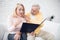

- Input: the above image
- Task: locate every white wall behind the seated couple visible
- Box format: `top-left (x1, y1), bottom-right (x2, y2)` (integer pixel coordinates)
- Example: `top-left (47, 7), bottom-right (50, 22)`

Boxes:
top-left (0, 0), bottom-right (60, 39)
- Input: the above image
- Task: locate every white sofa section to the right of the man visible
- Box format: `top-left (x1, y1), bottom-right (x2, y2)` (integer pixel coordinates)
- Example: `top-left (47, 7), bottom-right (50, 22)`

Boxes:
top-left (42, 20), bottom-right (60, 40)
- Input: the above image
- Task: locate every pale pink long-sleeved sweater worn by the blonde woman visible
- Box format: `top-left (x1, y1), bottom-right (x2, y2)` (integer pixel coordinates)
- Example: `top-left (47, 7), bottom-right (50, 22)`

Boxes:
top-left (8, 17), bottom-right (26, 33)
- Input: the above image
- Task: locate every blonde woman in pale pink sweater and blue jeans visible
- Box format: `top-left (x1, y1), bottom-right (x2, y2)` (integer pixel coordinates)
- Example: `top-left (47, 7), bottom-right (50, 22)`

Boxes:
top-left (8, 3), bottom-right (28, 40)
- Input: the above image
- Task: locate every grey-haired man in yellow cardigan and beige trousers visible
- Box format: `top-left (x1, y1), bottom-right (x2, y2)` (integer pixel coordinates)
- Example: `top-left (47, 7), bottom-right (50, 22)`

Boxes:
top-left (26, 5), bottom-right (54, 40)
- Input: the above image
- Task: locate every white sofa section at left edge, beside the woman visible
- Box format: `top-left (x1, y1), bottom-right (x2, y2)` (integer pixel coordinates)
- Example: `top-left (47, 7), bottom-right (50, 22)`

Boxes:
top-left (0, 24), bottom-right (8, 40)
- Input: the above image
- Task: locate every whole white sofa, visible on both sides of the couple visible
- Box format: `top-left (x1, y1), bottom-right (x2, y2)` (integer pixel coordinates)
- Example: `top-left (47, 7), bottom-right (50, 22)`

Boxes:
top-left (0, 21), bottom-right (60, 40)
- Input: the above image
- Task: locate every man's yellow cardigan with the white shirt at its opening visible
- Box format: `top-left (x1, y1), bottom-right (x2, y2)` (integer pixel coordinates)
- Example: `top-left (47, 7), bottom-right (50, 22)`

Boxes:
top-left (26, 12), bottom-right (43, 34)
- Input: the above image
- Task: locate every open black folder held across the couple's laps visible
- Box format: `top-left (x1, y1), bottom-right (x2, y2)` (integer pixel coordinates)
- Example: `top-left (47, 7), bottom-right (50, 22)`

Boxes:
top-left (20, 19), bottom-right (46, 33)
